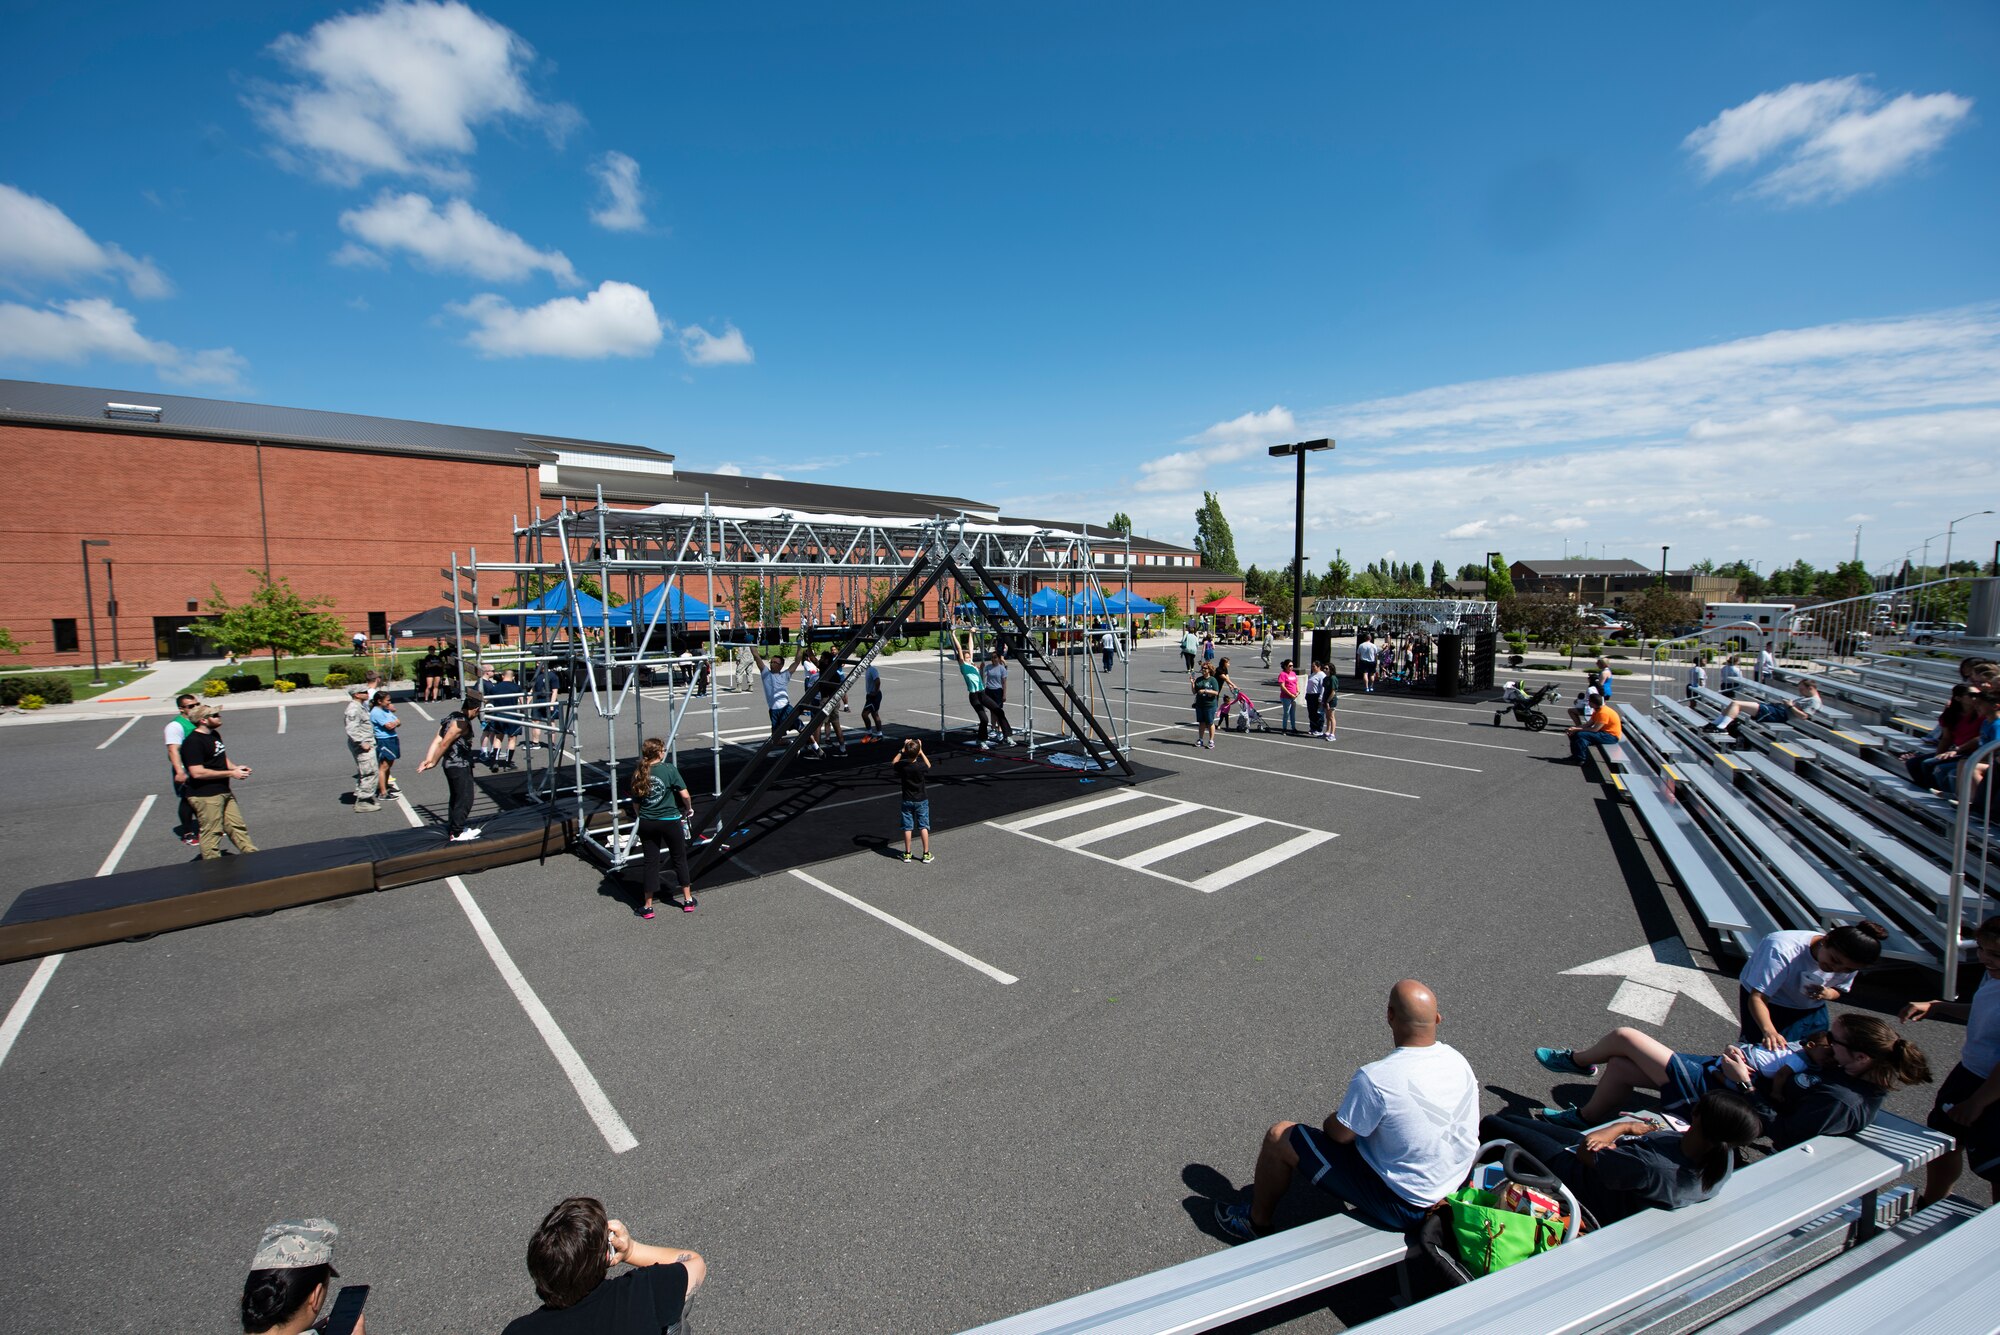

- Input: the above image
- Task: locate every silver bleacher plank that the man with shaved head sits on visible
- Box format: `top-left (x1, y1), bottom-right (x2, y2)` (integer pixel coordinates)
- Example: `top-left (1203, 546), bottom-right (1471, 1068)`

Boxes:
top-left (966, 1215), bottom-right (1408, 1335)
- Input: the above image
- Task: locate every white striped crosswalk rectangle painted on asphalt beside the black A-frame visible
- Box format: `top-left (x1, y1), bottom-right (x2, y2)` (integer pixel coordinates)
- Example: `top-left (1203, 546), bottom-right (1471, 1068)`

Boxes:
top-left (986, 789), bottom-right (1338, 895)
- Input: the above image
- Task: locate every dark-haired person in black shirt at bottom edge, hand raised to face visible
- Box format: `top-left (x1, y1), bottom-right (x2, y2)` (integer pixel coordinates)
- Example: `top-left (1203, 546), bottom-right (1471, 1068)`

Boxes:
top-left (504, 1195), bottom-right (708, 1335)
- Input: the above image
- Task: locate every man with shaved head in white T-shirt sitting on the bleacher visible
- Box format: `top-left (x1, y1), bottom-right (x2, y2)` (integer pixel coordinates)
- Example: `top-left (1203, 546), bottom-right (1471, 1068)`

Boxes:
top-left (1216, 977), bottom-right (1480, 1241)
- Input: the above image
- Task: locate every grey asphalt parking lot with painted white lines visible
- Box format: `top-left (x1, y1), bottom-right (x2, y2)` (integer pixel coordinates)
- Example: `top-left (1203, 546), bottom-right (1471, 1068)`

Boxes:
top-left (0, 648), bottom-right (1960, 1335)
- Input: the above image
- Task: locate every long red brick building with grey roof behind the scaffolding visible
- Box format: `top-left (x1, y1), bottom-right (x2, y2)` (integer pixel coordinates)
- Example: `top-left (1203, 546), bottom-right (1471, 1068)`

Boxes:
top-left (0, 380), bottom-right (1242, 666)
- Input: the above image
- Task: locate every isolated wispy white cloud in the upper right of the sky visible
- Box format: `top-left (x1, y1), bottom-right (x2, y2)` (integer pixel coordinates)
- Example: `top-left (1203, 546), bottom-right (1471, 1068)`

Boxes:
top-left (1682, 74), bottom-right (1972, 204)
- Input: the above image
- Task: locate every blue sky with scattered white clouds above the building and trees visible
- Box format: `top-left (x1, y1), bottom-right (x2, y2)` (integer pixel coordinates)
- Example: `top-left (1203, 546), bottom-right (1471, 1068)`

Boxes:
top-left (0, 2), bottom-right (2000, 568)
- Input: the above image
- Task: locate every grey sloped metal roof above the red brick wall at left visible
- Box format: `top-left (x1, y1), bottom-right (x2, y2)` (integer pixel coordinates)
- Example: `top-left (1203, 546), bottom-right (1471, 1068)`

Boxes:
top-left (0, 380), bottom-right (674, 464)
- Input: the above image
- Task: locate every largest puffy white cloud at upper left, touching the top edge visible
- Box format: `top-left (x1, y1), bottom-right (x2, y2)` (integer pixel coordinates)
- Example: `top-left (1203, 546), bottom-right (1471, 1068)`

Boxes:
top-left (250, 0), bottom-right (578, 190)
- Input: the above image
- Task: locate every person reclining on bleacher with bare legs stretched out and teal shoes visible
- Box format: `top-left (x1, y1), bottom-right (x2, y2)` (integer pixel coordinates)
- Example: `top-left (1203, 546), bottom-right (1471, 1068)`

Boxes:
top-left (1534, 1015), bottom-right (1930, 1149)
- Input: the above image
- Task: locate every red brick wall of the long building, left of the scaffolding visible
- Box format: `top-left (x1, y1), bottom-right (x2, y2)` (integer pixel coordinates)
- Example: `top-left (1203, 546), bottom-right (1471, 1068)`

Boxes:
top-left (0, 426), bottom-right (540, 666)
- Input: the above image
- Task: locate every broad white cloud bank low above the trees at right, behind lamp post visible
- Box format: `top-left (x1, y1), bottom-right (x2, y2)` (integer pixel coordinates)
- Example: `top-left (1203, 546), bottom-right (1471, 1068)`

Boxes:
top-left (1004, 306), bottom-right (2000, 570)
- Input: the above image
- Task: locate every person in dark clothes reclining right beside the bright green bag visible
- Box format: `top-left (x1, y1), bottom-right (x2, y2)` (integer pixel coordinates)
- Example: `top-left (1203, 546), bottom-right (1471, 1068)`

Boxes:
top-left (1480, 1089), bottom-right (1764, 1225)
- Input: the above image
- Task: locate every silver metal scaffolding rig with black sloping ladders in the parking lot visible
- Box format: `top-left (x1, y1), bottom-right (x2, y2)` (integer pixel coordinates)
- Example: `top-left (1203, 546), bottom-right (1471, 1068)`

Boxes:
top-left (448, 494), bottom-right (1134, 869)
